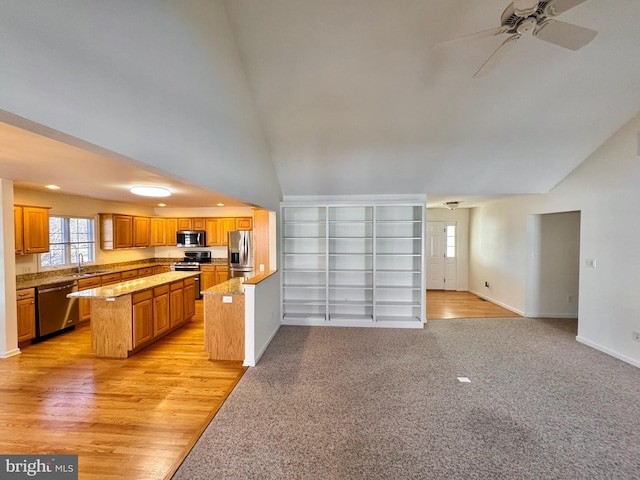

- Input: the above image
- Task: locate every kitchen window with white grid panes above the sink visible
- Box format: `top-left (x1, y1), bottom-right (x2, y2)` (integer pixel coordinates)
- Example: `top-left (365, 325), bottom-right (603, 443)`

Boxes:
top-left (40, 216), bottom-right (95, 268)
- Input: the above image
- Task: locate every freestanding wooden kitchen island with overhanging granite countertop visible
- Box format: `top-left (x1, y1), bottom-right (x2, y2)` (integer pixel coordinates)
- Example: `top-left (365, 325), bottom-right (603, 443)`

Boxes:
top-left (68, 271), bottom-right (199, 358)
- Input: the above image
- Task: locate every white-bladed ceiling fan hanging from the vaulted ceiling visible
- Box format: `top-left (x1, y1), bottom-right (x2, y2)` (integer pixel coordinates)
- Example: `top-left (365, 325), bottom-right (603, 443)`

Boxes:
top-left (434, 0), bottom-right (598, 78)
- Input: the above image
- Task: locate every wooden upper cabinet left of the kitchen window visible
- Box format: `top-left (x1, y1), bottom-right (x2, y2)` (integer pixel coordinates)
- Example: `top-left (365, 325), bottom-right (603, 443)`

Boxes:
top-left (13, 205), bottom-right (49, 254)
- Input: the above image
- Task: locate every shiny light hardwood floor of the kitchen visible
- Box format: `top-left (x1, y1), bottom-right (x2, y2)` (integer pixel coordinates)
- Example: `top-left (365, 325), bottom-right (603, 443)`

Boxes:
top-left (0, 301), bottom-right (245, 480)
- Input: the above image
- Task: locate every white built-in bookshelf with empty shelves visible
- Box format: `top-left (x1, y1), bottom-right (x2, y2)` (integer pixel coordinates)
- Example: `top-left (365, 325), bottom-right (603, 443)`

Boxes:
top-left (280, 203), bottom-right (425, 328)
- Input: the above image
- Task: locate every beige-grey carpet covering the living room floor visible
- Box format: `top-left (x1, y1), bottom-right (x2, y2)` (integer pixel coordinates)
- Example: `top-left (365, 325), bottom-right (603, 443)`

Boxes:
top-left (174, 318), bottom-right (640, 480)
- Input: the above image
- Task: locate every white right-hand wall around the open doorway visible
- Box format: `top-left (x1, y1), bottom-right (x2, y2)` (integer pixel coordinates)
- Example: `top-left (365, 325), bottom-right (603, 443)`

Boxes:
top-left (469, 115), bottom-right (640, 366)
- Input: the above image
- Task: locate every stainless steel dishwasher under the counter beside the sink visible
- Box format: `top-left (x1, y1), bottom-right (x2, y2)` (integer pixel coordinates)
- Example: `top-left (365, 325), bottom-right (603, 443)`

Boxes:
top-left (35, 280), bottom-right (80, 341)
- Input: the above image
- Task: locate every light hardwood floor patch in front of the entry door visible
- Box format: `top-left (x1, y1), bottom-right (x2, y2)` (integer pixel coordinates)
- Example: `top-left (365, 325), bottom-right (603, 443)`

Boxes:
top-left (427, 290), bottom-right (520, 320)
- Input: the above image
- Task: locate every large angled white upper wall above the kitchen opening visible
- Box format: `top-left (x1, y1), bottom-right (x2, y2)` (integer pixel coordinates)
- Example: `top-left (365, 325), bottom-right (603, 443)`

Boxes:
top-left (0, 0), bottom-right (281, 210)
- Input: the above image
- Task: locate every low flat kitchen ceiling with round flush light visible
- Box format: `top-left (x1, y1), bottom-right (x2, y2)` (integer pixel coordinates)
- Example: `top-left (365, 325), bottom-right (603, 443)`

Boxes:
top-left (0, 118), bottom-right (252, 208)
